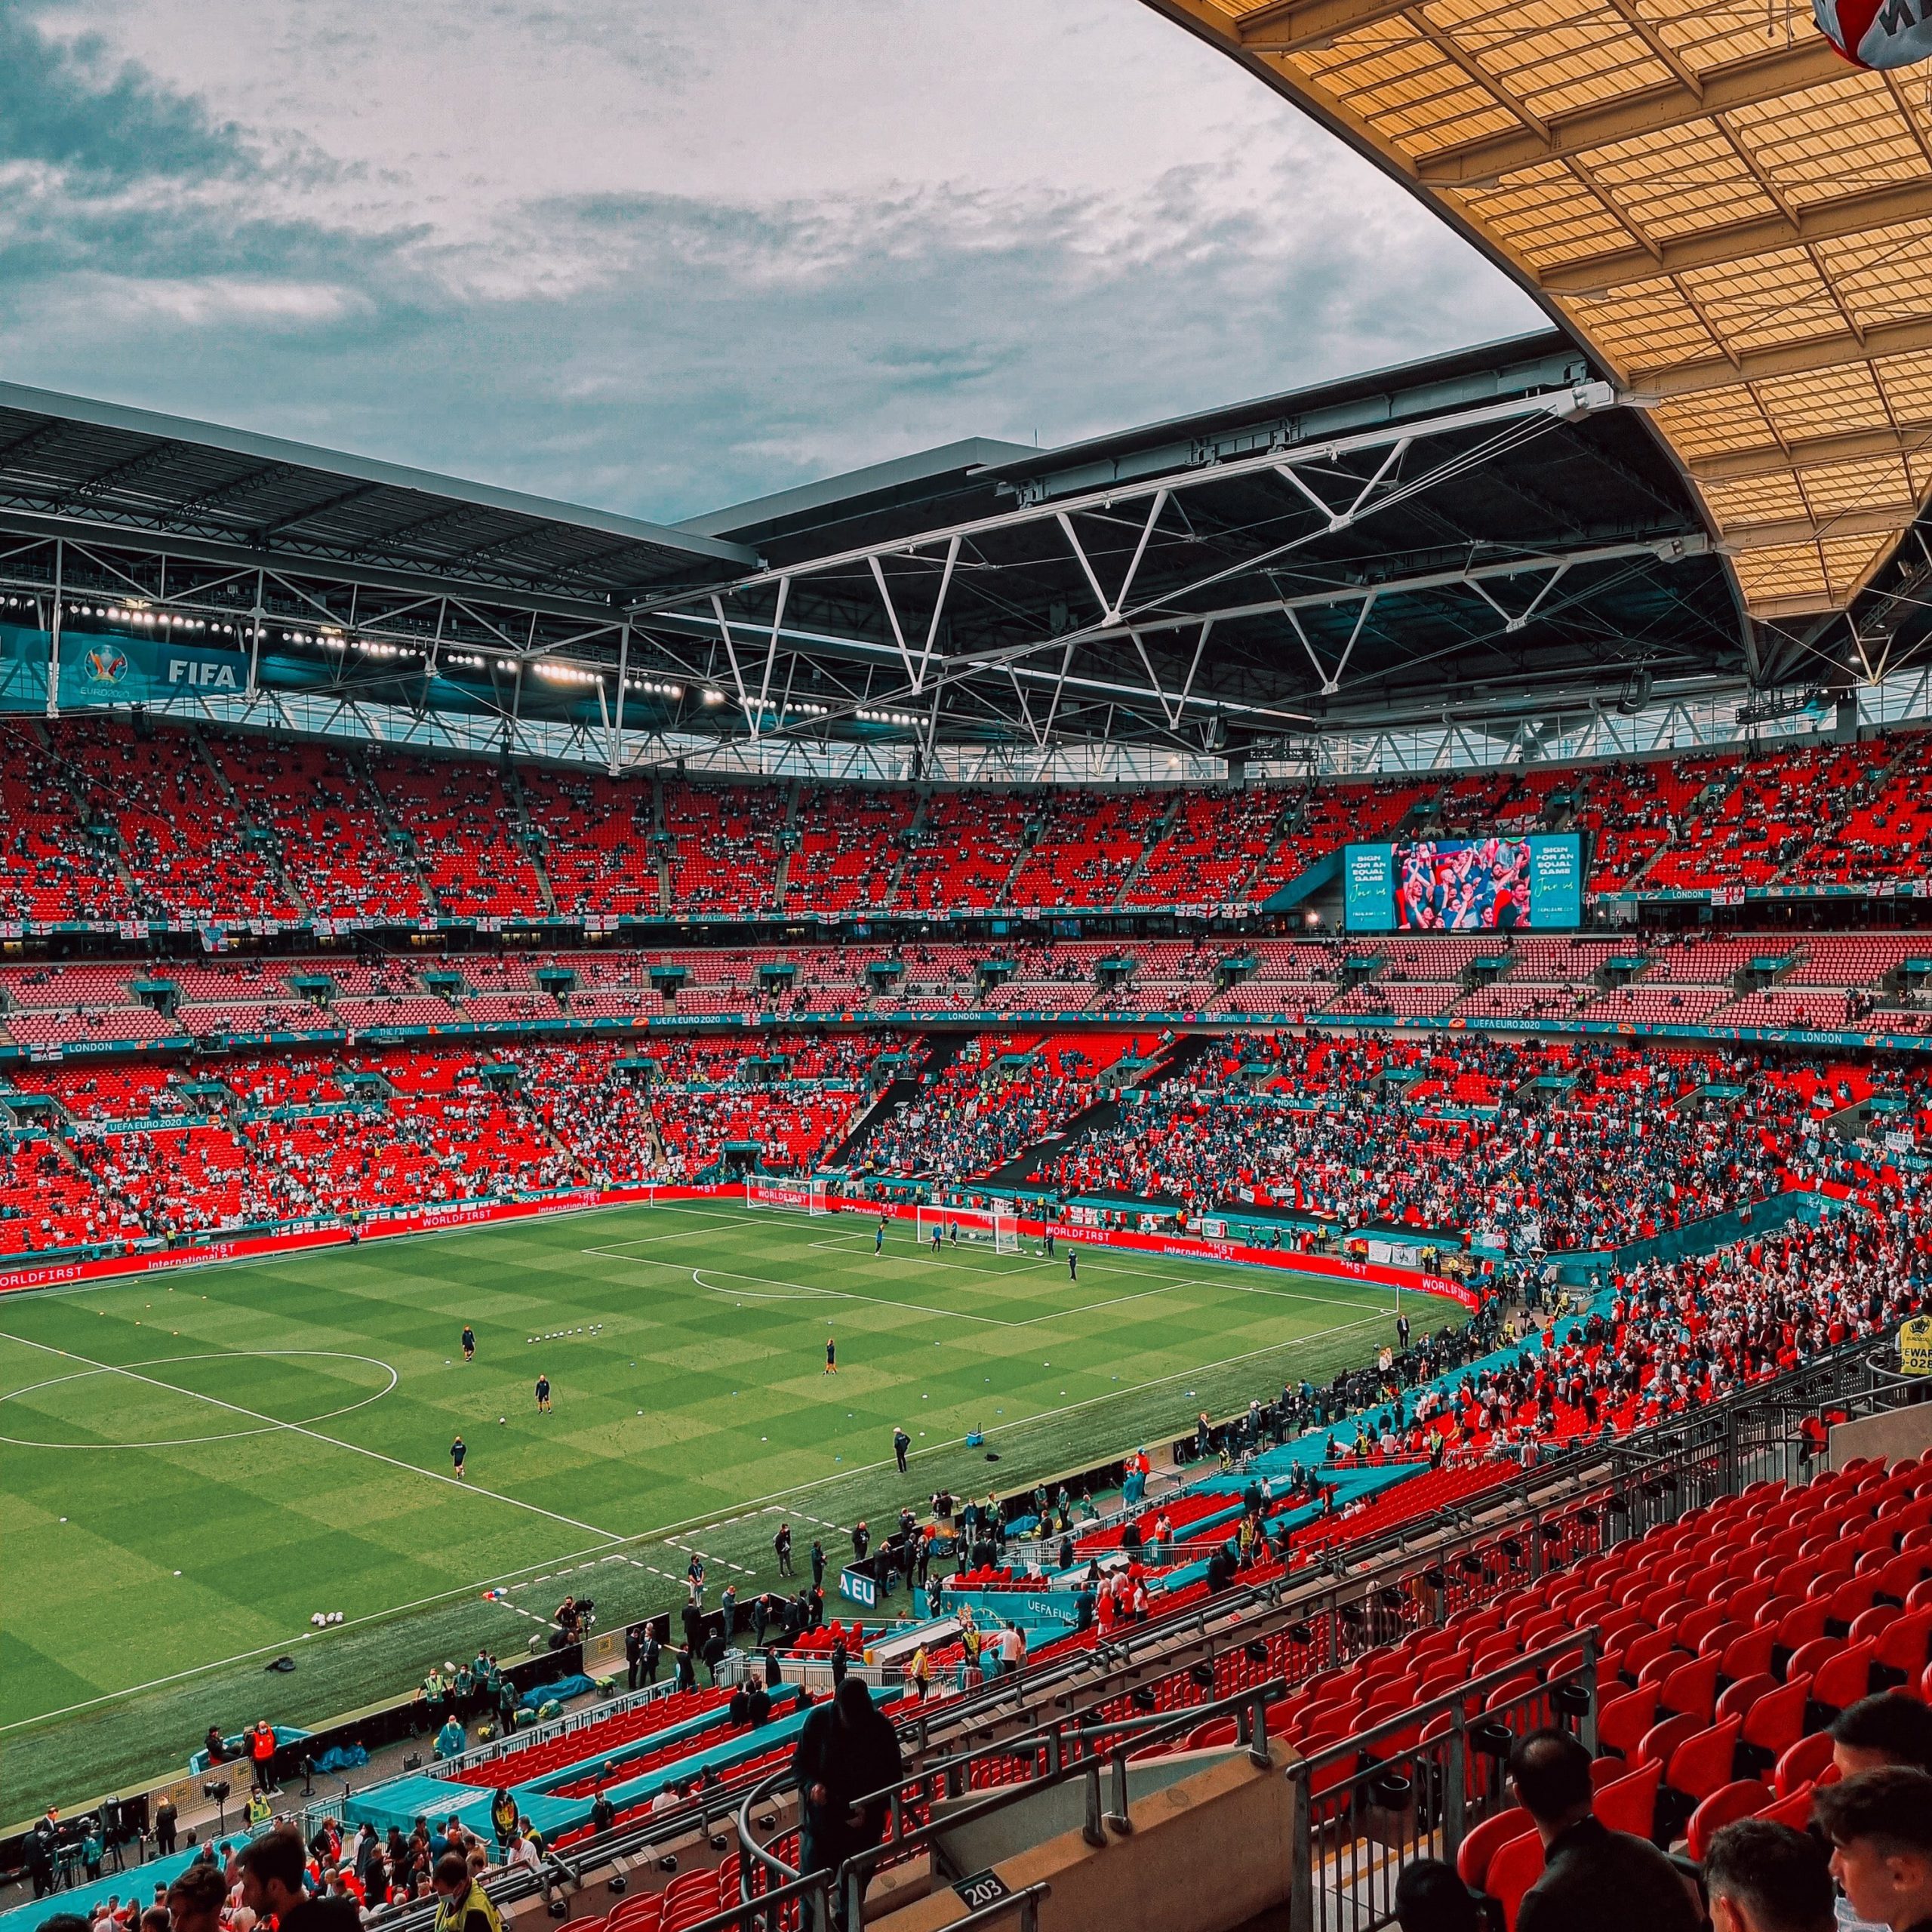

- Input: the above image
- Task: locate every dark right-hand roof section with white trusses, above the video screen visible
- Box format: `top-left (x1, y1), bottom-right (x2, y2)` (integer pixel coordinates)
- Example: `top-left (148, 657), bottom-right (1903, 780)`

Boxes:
top-left (634, 332), bottom-right (1746, 752)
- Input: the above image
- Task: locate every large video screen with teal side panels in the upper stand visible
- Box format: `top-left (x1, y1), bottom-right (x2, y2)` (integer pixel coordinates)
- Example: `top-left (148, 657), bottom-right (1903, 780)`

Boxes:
top-left (1343, 832), bottom-right (1583, 933)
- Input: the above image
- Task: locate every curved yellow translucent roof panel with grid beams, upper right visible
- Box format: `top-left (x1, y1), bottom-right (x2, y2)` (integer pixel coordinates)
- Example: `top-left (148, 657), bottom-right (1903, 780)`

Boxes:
top-left (1146, 0), bottom-right (1932, 620)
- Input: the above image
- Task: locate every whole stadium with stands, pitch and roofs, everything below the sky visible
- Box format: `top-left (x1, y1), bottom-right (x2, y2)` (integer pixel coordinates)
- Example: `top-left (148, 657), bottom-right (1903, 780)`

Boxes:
top-left (0, 42), bottom-right (1932, 1932)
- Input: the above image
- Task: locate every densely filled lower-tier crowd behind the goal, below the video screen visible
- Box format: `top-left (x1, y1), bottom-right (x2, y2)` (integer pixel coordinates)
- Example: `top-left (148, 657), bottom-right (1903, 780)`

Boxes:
top-left (1012, 1035), bottom-right (1932, 1252)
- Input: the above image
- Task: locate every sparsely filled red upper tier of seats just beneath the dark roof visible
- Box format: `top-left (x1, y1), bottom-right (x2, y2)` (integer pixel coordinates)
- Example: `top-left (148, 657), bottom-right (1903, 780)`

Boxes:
top-left (15, 717), bottom-right (1932, 943)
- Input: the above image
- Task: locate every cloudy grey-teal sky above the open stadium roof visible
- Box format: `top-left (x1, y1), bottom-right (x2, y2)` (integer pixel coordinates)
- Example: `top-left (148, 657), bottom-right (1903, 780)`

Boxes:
top-left (0, 0), bottom-right (1538, 520)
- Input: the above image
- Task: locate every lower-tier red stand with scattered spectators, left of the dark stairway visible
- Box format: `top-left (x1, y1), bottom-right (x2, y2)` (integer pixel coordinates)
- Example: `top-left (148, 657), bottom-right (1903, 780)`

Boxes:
top-left (0, 1032), bottom-right (939, 1254)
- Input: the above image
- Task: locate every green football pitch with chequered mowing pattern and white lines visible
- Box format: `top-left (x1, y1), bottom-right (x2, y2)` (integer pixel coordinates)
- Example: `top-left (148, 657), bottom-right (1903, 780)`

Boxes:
top-left (0, 1201), bottom-right (1406, 1826)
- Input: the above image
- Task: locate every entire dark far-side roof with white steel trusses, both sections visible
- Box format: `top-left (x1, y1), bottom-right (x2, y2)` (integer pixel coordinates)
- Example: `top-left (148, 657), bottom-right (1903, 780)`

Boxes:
top-left (0, 331), bottom-right (1750, 763)
